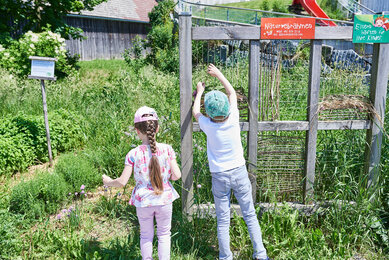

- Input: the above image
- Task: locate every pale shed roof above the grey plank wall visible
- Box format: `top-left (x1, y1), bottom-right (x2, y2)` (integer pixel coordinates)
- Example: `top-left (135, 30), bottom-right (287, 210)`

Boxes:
top-left (76, 0), bottom-right (157, 22)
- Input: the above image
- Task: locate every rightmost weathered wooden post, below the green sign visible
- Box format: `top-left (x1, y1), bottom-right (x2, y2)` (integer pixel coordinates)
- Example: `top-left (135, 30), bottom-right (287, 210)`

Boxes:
top-left (364, 43), bottom-right (389, 189)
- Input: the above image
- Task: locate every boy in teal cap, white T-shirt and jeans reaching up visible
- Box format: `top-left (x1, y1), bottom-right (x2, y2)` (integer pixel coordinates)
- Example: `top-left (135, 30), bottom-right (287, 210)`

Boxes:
top-left (192, 64), bottom-right (269, 260)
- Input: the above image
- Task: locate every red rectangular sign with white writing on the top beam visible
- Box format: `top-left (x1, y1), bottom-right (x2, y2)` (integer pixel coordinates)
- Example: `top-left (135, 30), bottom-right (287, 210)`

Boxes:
top-left (261, 18), bottom-right (315, 39)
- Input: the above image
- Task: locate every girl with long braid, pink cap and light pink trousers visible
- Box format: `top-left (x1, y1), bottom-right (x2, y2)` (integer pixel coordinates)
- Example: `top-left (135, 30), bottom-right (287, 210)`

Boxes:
top-left (103, 106), bottom-right (181, 260)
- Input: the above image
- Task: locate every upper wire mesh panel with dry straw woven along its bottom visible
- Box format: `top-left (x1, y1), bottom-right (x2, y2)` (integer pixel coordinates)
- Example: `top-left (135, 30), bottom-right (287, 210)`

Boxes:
top-left (319, 44), bottom-right (373, 120)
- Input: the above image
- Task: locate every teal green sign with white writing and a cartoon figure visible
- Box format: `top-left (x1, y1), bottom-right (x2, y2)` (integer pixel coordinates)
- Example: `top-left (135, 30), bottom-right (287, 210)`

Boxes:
top-left (353, 14), bottom-right (389, 43)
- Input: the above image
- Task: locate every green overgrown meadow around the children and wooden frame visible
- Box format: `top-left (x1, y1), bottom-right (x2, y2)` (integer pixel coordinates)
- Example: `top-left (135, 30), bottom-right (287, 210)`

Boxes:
top-left (0, 60), bottom-right (389, 259)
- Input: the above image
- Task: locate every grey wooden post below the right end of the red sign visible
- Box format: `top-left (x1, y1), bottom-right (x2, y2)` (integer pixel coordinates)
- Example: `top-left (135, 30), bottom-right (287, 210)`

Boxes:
top-left (304, 40), bottom-right (322, 203)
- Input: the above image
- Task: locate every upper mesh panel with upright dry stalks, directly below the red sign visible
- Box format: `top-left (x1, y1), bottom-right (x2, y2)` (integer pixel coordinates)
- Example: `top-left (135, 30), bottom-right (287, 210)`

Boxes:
top-left (259, 40), bottom-right (309, 121)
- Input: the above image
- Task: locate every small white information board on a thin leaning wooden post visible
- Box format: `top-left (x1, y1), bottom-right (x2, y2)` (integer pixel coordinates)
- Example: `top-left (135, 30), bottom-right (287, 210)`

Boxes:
top-left (28, 56), bottom-right (57, 167)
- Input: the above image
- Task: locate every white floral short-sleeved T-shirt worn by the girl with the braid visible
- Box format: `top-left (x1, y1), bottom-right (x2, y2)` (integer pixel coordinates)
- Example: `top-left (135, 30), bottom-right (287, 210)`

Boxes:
top-left (125, 143), bottom-right (179, 207)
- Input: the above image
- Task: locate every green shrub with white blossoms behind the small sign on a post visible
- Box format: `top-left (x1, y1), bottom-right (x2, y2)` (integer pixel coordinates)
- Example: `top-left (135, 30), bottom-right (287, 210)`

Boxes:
top-left (0, 29), bottom-right (78, 77)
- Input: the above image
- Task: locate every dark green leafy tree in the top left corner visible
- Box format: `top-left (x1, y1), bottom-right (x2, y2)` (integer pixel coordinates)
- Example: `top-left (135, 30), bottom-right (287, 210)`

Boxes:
top-left (0, 0), bottom-right (107, 40)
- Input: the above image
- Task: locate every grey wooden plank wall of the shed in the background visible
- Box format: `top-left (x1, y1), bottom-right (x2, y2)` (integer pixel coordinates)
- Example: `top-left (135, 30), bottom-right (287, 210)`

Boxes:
top-left (66, 17), bottom-right (149, 60)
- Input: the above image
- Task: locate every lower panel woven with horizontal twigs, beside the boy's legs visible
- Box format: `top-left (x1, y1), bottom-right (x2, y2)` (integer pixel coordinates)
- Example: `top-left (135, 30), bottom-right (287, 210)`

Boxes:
top-left (257, 132), bottom-right (305, 201)
